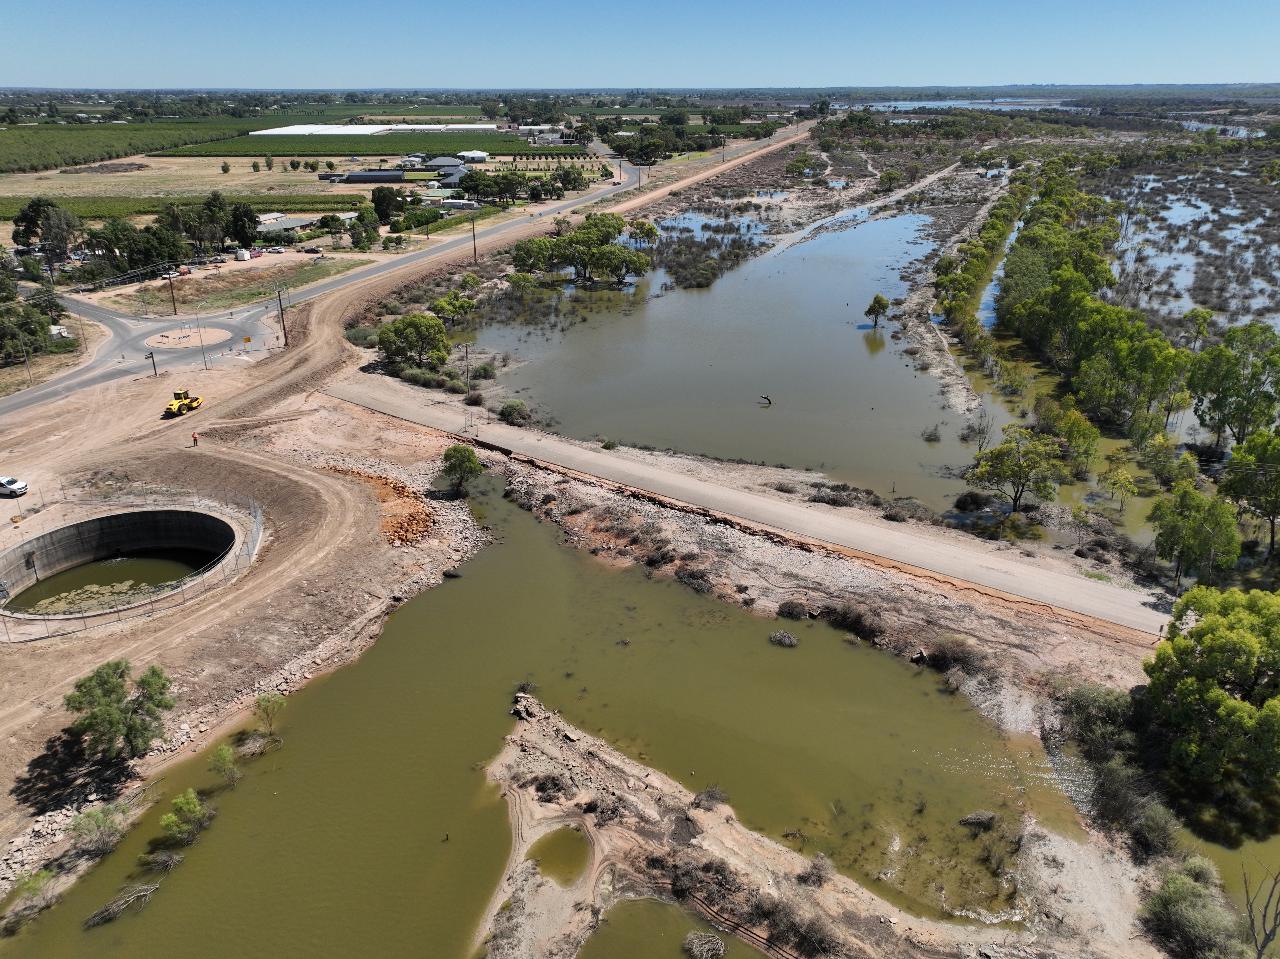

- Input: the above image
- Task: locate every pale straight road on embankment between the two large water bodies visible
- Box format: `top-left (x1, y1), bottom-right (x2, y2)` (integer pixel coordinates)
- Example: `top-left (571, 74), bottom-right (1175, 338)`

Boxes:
top-left (325, 375), bottom-right (1169, 634)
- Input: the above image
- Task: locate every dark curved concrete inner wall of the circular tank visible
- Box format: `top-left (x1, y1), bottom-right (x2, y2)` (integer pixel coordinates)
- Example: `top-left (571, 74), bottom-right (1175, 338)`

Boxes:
top-left (0, 510), bottom-right (238, 606)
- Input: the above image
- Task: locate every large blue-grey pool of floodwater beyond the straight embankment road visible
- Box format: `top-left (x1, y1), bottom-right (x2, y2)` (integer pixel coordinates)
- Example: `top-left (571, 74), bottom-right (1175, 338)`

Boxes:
top-left (476, 211), bottom-right (1010, 510)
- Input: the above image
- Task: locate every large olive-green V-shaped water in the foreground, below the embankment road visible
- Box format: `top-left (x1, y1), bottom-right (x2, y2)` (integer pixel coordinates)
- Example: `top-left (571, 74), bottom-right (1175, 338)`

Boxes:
top-left (0, 478), bottom-right (1078, 959)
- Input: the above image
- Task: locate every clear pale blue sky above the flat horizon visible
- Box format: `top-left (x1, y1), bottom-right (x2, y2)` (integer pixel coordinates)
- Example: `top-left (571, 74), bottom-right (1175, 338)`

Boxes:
top-left (0, 0), bottom-right (1280, 88)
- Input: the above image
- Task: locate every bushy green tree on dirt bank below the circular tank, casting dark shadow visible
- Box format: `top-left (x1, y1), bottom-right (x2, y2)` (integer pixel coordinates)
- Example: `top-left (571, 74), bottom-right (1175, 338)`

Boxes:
top-left (63, 659), bottom-right (174, 759)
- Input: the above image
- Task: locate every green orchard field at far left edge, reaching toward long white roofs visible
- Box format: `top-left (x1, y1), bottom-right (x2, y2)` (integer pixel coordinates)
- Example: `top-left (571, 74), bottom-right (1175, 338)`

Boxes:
top-left (0, 115), bottom-right (340, 173)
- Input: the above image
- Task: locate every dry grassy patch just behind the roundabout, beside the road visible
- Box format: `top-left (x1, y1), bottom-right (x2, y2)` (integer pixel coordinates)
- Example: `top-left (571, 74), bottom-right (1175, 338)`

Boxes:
top-left (108, 257), bottom-right (372, 314)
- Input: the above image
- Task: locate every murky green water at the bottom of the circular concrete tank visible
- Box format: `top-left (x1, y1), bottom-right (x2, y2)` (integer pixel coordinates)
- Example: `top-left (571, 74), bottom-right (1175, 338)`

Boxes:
top-left (5, 549), bottom-right (212, 613)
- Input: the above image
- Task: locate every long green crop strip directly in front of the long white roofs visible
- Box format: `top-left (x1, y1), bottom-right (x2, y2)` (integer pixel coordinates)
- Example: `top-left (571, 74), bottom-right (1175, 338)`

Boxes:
top-left (154, 133), bottom-right (584, 157)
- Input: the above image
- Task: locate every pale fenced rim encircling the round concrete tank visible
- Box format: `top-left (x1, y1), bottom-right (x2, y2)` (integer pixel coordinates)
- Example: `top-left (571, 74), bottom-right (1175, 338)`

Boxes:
top-left (0, 488), bottom-right (265, 643)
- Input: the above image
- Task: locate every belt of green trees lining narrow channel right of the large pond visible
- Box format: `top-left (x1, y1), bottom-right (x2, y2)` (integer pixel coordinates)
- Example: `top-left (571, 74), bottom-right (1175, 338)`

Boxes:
top-left (938, 159), bottom-right (1280, 588)
